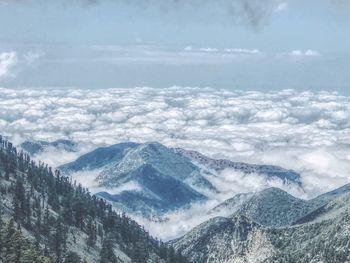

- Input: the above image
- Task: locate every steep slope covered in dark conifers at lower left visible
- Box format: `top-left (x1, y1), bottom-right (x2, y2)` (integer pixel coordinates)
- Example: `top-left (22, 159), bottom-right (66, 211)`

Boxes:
top-left (0, 136), bottom-right (187, 263)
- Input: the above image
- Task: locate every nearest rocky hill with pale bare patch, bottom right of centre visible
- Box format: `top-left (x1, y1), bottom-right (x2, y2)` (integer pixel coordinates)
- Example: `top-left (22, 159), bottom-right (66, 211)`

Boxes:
top-left (170, 215), bottom-right (274, 263)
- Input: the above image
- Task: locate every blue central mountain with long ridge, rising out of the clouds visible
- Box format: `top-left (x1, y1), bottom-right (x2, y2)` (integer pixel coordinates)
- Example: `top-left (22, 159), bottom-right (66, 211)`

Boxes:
top-left (59, 142), bottom-right (300, 218)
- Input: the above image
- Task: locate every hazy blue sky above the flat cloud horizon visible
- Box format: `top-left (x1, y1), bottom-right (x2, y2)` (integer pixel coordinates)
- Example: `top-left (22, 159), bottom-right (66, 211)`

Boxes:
top-left (0, 0), bottom-right (350, 93)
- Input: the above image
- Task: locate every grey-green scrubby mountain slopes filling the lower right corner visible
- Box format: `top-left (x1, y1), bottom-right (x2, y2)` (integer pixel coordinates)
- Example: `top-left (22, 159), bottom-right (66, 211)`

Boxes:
top-left (170, 186), bottom-right (350, 263)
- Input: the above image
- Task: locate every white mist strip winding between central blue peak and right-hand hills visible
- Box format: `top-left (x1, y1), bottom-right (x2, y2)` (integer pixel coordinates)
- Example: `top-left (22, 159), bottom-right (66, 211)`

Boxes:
top-left (134, 169), bottom-right (304, 240)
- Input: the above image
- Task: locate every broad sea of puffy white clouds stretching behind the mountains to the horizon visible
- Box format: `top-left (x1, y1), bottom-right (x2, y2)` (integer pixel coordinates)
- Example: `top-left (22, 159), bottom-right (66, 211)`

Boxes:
top-left (0, 87), bottom-right (350, 200)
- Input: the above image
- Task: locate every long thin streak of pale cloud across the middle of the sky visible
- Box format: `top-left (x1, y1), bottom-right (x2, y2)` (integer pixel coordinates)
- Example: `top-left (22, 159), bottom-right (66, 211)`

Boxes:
top-left (57, 43), bottom-right (323, 65)
